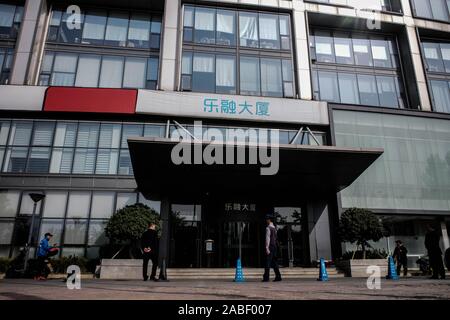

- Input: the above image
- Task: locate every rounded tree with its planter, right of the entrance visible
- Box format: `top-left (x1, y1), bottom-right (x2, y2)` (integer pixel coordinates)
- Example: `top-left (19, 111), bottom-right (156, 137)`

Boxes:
top-left (337, 208), bottom-right (387, 277)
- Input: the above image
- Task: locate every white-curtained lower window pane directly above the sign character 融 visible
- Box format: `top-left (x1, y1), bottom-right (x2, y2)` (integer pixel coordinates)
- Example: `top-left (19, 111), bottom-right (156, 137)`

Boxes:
top-left (216, 56), bottom-right (236, 94)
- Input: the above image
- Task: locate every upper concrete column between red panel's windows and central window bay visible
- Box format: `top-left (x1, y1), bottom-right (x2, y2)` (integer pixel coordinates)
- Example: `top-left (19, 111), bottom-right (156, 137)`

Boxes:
top-left (159, 0), bottom-right (181, 91)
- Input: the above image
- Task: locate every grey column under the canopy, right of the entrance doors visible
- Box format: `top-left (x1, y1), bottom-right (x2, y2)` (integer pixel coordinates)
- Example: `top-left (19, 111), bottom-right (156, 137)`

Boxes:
top-left (307, 201), bottom-right (332, 261)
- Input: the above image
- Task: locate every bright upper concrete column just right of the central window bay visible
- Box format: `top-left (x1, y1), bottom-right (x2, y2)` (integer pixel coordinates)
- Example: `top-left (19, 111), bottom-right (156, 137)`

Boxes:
top-left (292, 1), bottom-right (312, 100)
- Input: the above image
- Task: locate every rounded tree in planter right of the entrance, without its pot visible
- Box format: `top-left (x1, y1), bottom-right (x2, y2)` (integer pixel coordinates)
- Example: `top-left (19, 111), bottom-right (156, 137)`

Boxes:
top-left (338, 208), bottom-right (384, 259)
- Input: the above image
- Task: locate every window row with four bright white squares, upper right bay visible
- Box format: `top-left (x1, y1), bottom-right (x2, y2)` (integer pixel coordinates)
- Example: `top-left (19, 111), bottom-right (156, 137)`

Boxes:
top-left (310, 30), bottom-right (399, 68)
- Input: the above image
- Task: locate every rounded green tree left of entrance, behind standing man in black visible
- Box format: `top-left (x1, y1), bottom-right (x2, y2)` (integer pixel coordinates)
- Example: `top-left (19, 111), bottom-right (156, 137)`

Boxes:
top-left (105, 203), bottom-right (161, 258)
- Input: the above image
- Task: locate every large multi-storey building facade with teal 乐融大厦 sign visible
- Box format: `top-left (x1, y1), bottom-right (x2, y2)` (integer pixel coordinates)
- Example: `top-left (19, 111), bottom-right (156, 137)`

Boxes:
top-left (0, 0), bottom-right (450, 267)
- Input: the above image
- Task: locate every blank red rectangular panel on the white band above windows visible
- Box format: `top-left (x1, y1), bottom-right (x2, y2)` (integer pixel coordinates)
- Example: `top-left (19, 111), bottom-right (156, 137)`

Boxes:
top-left (44, 87), bottom-right (138, 114)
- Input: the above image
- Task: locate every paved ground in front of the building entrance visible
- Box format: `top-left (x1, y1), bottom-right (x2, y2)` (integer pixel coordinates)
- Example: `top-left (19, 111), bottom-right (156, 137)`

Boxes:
top-left (0, 277), bottom-right (450, 300)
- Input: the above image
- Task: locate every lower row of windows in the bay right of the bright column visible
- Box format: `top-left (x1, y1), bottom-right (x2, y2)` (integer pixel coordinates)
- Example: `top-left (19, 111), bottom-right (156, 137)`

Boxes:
top-left (313, 71), bottom-right (404, 108)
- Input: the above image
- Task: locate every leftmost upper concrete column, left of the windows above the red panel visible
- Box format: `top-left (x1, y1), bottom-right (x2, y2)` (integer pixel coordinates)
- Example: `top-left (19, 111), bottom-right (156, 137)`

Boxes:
top-left (10, 0), bottom-right (45, 85)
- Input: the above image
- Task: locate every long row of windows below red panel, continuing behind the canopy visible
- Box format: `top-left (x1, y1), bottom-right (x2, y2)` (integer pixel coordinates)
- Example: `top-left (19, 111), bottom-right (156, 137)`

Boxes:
top-left (0, 120), bottom-right (325, 175)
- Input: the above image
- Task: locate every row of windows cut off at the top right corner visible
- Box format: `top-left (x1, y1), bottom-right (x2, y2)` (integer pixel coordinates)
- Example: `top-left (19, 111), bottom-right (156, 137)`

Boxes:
top-left (411, 0), bottom-right (450, 22)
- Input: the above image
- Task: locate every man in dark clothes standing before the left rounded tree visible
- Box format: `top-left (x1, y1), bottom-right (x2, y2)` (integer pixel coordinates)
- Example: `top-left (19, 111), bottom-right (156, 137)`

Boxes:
top-left (141, 222), bottom-right (158, 281)
